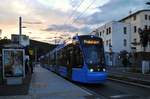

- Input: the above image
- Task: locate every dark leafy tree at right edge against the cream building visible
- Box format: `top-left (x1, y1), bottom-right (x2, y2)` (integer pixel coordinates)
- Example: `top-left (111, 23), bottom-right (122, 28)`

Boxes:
top-left (138, 29), bottom-right (150, 52)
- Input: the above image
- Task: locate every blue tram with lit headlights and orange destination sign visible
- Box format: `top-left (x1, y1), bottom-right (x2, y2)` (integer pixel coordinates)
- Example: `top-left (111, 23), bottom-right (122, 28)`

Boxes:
top-left (42, 35), bottom-right (107, 83)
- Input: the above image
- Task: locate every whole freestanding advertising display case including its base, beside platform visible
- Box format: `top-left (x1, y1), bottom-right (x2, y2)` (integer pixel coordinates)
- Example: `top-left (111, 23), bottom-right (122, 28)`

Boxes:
top-left (2, 44), bottom-right (25, 85)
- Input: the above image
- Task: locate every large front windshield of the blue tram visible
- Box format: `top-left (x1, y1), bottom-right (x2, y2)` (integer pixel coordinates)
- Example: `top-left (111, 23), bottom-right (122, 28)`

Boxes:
top-left (83, 45), bottom-right (104, 65)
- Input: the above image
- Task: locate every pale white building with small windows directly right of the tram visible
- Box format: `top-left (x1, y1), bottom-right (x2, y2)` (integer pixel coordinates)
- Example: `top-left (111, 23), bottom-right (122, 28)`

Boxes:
top-left (92, 21), bottom-right (131, 65)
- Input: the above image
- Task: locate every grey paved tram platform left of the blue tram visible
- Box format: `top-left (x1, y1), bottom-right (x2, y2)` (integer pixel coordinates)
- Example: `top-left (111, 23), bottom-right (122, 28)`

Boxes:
top-left (0, 66), bottom-right (92, 99)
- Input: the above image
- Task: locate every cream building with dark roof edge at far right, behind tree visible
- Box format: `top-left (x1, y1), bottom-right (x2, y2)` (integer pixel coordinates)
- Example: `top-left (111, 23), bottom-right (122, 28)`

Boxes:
top-left (119, 9), bottom-right (150, 52)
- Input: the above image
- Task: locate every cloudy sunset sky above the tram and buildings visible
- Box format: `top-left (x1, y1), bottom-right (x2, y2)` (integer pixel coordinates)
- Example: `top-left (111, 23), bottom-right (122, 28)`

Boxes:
top-left (0, 0), bottom-right (149, 43)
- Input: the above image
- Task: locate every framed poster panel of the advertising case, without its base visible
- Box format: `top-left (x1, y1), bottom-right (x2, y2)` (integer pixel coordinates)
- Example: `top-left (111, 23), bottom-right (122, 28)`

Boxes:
top-left (3, 49), bottom-right (25, 78)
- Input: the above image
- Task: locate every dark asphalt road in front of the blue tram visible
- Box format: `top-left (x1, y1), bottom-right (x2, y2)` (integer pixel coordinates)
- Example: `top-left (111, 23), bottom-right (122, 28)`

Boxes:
top-left (77, 80), bottom-right (150, 99)
